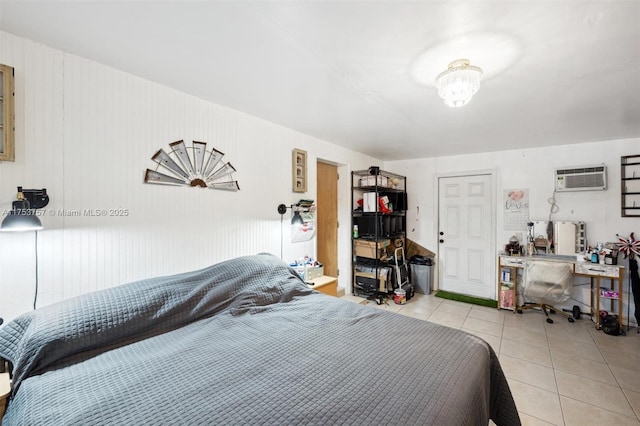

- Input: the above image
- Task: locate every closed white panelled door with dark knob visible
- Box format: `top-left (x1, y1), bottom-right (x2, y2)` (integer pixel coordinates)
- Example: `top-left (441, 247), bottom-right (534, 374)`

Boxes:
top-left (438, 174), bottom-right (496, 299)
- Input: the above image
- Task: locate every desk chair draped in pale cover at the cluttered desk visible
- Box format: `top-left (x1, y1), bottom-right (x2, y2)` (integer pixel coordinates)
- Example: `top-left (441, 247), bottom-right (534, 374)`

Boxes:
top-left (517, 261), bottom-right (574, 324)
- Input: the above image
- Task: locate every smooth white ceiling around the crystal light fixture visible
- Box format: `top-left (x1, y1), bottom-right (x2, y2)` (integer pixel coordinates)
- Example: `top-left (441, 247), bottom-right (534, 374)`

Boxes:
top-left (0, 0), bottom-right (640, 160)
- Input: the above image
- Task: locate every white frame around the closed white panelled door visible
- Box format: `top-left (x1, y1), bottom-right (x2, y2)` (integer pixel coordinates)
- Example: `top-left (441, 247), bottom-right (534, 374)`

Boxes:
top-left (433, 169), bottom-right (498, 300)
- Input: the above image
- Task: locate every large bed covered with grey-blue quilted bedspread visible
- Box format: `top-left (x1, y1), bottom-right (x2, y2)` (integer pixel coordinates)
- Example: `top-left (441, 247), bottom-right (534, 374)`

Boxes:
top-left (0, 254), bottom-right (520, 426)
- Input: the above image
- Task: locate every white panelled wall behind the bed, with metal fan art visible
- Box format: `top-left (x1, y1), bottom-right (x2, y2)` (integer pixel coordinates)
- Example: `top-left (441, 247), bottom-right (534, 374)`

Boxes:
top-left (0, 32), bottom-right (379, 320)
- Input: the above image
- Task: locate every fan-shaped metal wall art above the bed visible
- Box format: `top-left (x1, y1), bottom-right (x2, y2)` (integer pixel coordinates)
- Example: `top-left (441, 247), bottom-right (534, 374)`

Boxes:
top-left (144, 140), bottom-right (240, 192)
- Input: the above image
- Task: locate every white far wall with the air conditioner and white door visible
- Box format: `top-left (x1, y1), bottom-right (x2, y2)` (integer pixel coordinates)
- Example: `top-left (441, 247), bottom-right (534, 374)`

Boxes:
top-left (384, 139), bottom-right (640, 322)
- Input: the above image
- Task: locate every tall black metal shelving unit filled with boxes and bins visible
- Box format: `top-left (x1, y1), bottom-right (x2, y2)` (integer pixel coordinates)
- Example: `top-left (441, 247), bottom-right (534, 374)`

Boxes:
top-left (351, 167), bottom-right (407, 297)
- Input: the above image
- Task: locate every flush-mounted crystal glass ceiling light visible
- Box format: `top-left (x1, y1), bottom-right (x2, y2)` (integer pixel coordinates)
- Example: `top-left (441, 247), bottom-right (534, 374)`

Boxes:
top-left (436, 59), bottom-right (482, 107)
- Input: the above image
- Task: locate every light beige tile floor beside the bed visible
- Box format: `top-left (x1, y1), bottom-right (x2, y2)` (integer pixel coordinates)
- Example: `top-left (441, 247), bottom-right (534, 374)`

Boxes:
top-left (342, 294), bottom-right (640, 426)
